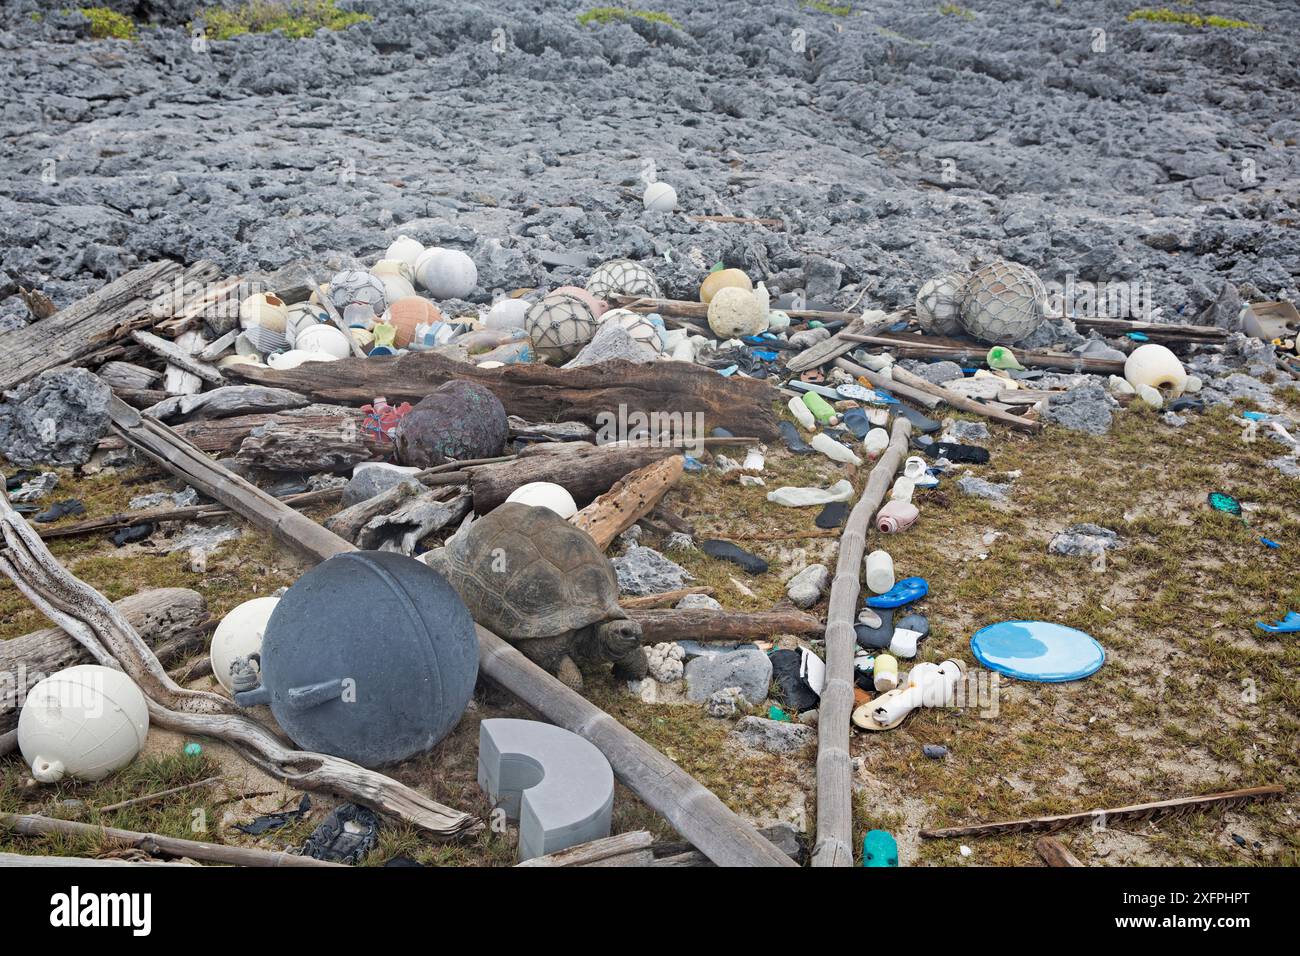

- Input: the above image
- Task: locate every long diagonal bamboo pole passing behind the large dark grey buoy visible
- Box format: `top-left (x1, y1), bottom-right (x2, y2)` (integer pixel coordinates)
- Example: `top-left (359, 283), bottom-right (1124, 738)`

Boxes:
top-left (104, 395), bottom-right (793, 866)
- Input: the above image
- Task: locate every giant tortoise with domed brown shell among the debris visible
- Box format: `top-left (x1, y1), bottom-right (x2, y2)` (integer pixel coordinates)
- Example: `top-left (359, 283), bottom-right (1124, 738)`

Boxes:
top-left (436, 502), bottom-right (649, 688)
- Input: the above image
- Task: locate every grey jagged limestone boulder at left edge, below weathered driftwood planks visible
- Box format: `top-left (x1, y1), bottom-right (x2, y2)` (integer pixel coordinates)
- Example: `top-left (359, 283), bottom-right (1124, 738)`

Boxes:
top-left (0, 368), bottom-right (113, 467)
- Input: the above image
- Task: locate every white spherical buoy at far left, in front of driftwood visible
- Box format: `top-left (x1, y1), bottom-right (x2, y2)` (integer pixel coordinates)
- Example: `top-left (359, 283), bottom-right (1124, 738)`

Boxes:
top-left (18, 663), bottom-right (150, 783)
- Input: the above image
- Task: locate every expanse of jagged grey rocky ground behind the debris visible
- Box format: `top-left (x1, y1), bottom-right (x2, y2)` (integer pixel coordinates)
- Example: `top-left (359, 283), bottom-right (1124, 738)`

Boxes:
top-left (0, 0), bottom-right (1300, 328)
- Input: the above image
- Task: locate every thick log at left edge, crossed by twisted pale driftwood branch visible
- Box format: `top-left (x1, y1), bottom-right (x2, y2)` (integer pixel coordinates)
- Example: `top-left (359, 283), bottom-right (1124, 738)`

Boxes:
top-left (0, 588), bottom-right (208, 732)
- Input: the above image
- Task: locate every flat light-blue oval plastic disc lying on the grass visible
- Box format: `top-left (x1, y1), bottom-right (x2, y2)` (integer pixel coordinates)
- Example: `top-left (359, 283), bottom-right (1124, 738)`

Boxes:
top-left (971, 620), bottom-right (1106, 683)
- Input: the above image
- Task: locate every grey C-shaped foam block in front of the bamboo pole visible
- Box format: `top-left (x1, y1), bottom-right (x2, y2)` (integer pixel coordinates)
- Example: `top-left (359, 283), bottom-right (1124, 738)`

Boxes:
top-left (478, 718), bottom-right (614, 861)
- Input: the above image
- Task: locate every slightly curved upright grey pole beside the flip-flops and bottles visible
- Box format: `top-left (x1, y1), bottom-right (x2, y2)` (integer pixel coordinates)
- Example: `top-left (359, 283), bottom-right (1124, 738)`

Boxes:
top-left (813, 418), bottom-right (911, 866)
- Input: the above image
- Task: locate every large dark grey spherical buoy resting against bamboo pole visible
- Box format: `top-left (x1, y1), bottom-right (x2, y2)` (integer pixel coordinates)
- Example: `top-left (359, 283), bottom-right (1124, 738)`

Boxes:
top-left (235, 551), bottom-right (478, 767)
